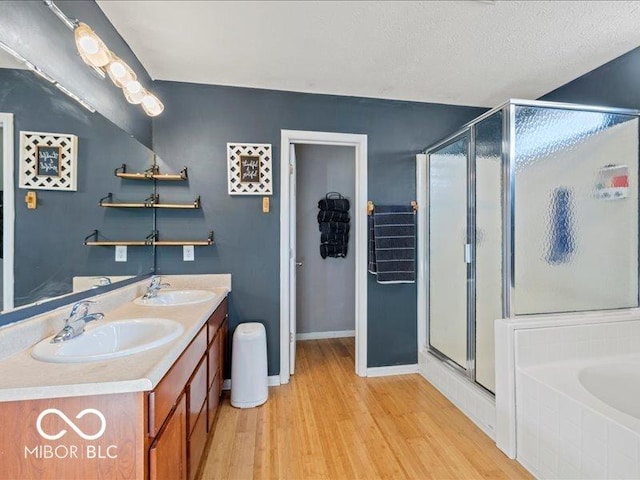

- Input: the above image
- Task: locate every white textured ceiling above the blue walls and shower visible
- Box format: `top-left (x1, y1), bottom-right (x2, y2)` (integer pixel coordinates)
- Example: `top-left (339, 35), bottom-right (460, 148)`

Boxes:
top-left (96, 0), bottom-right (640, 107)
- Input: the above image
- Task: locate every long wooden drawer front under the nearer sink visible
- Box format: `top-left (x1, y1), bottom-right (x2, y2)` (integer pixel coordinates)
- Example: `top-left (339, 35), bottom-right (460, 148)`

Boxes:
top-left (149, 327), bottom-right (207, 437)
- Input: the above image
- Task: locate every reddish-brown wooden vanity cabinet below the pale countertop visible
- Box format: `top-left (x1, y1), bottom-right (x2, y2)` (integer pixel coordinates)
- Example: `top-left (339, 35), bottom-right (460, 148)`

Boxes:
top-left (0, 299), bottom-right (227, 480)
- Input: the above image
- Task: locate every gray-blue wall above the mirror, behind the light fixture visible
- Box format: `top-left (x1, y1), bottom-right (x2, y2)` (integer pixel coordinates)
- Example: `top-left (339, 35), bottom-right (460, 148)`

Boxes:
top-left (0, 0), bottom-right (151, 146)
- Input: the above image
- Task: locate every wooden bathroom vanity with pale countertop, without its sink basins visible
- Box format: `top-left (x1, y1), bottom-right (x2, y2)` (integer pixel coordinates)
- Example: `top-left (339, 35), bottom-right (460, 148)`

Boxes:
top-left (0, 275), bottom-right (230, 480)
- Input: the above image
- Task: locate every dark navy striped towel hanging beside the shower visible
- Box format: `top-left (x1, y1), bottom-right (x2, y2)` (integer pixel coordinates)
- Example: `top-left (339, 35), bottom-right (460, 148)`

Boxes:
top-left (373, 205), bottom-right (416, 284)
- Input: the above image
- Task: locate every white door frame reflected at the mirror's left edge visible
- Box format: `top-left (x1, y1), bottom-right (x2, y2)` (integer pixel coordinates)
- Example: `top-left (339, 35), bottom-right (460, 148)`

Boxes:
top-left (0, 113), bottom-right (15, 310)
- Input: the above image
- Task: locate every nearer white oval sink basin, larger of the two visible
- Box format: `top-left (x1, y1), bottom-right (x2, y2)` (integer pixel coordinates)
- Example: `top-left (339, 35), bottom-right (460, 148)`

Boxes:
top-left (31, 318), bottom-right (184, 363)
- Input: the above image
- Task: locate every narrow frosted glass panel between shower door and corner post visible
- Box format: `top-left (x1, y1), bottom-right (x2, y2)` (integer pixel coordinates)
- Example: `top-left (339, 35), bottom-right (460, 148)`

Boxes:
top-left (475, 112), bottom-right (503, 392)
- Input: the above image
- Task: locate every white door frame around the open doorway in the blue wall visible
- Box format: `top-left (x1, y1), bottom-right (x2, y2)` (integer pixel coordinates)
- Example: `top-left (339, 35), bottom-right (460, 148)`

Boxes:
top-left (280, 130), bottom-right (368, 384)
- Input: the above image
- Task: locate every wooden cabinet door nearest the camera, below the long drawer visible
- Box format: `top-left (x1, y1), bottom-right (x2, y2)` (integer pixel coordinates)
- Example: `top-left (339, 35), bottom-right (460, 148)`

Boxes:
top-left (149, 395), bottom-right (187, 480)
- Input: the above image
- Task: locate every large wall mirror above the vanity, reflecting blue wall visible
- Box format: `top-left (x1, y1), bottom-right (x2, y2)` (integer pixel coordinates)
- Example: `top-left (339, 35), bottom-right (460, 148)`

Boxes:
top-left (0, 51), bottom-right (154, 316)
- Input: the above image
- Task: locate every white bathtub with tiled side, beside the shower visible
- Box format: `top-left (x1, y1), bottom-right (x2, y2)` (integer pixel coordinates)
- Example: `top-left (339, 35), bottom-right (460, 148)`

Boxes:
top-left (516, 354), bottom-right (640, 479)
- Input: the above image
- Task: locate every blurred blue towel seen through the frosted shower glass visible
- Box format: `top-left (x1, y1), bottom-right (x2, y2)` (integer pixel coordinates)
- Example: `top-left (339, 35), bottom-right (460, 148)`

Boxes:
top-left (547, 187), bottom-right (575, 265)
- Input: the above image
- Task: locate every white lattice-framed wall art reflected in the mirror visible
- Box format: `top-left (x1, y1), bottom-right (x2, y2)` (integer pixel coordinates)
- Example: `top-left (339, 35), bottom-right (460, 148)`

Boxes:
top-left (19, 131), bottom-right (78, 192)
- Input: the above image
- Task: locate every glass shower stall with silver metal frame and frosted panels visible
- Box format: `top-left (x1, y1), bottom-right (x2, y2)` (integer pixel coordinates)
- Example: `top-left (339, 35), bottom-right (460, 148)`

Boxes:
top-left (423, 100), bottom-right (639, 392)
